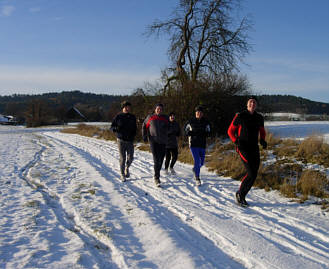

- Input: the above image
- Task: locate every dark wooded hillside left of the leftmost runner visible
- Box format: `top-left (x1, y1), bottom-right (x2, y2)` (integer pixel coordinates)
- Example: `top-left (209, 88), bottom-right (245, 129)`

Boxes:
top-left (0, 91), bottom-right (124, 127)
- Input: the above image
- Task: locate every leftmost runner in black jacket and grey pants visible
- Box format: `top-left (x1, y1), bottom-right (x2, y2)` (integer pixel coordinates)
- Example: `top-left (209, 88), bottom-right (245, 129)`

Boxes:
top-left (111, 101), bottom-right (137, 182)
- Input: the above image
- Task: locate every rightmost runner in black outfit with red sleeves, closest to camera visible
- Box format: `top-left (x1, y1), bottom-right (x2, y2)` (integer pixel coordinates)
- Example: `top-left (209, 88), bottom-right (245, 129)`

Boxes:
top-left (228, 96), bottom-right (267, 206)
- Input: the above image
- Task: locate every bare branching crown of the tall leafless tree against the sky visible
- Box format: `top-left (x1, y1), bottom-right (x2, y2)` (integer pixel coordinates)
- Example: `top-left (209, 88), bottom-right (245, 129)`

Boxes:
top-left (147, 0), bottom-right (250, 88)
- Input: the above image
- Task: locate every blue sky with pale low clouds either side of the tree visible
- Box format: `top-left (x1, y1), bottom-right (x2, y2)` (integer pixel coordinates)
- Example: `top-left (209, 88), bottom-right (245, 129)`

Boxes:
top-left (0, 0), bottom-right (329, 102)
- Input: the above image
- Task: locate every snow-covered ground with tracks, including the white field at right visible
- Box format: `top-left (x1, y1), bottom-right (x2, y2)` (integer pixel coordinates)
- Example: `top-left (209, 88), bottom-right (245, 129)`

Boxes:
top-left (0, 122), bottom-right (329, 269)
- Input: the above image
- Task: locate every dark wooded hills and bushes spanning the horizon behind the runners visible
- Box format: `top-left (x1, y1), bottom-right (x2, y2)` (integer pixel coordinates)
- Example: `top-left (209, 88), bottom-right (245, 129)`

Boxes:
top-left (0, 89), bottom-right (329, 130)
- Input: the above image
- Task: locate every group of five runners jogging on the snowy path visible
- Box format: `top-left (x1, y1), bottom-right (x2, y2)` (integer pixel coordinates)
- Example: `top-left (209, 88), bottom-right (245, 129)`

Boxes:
top-left (111, 96), bottom-right (267, 207)
